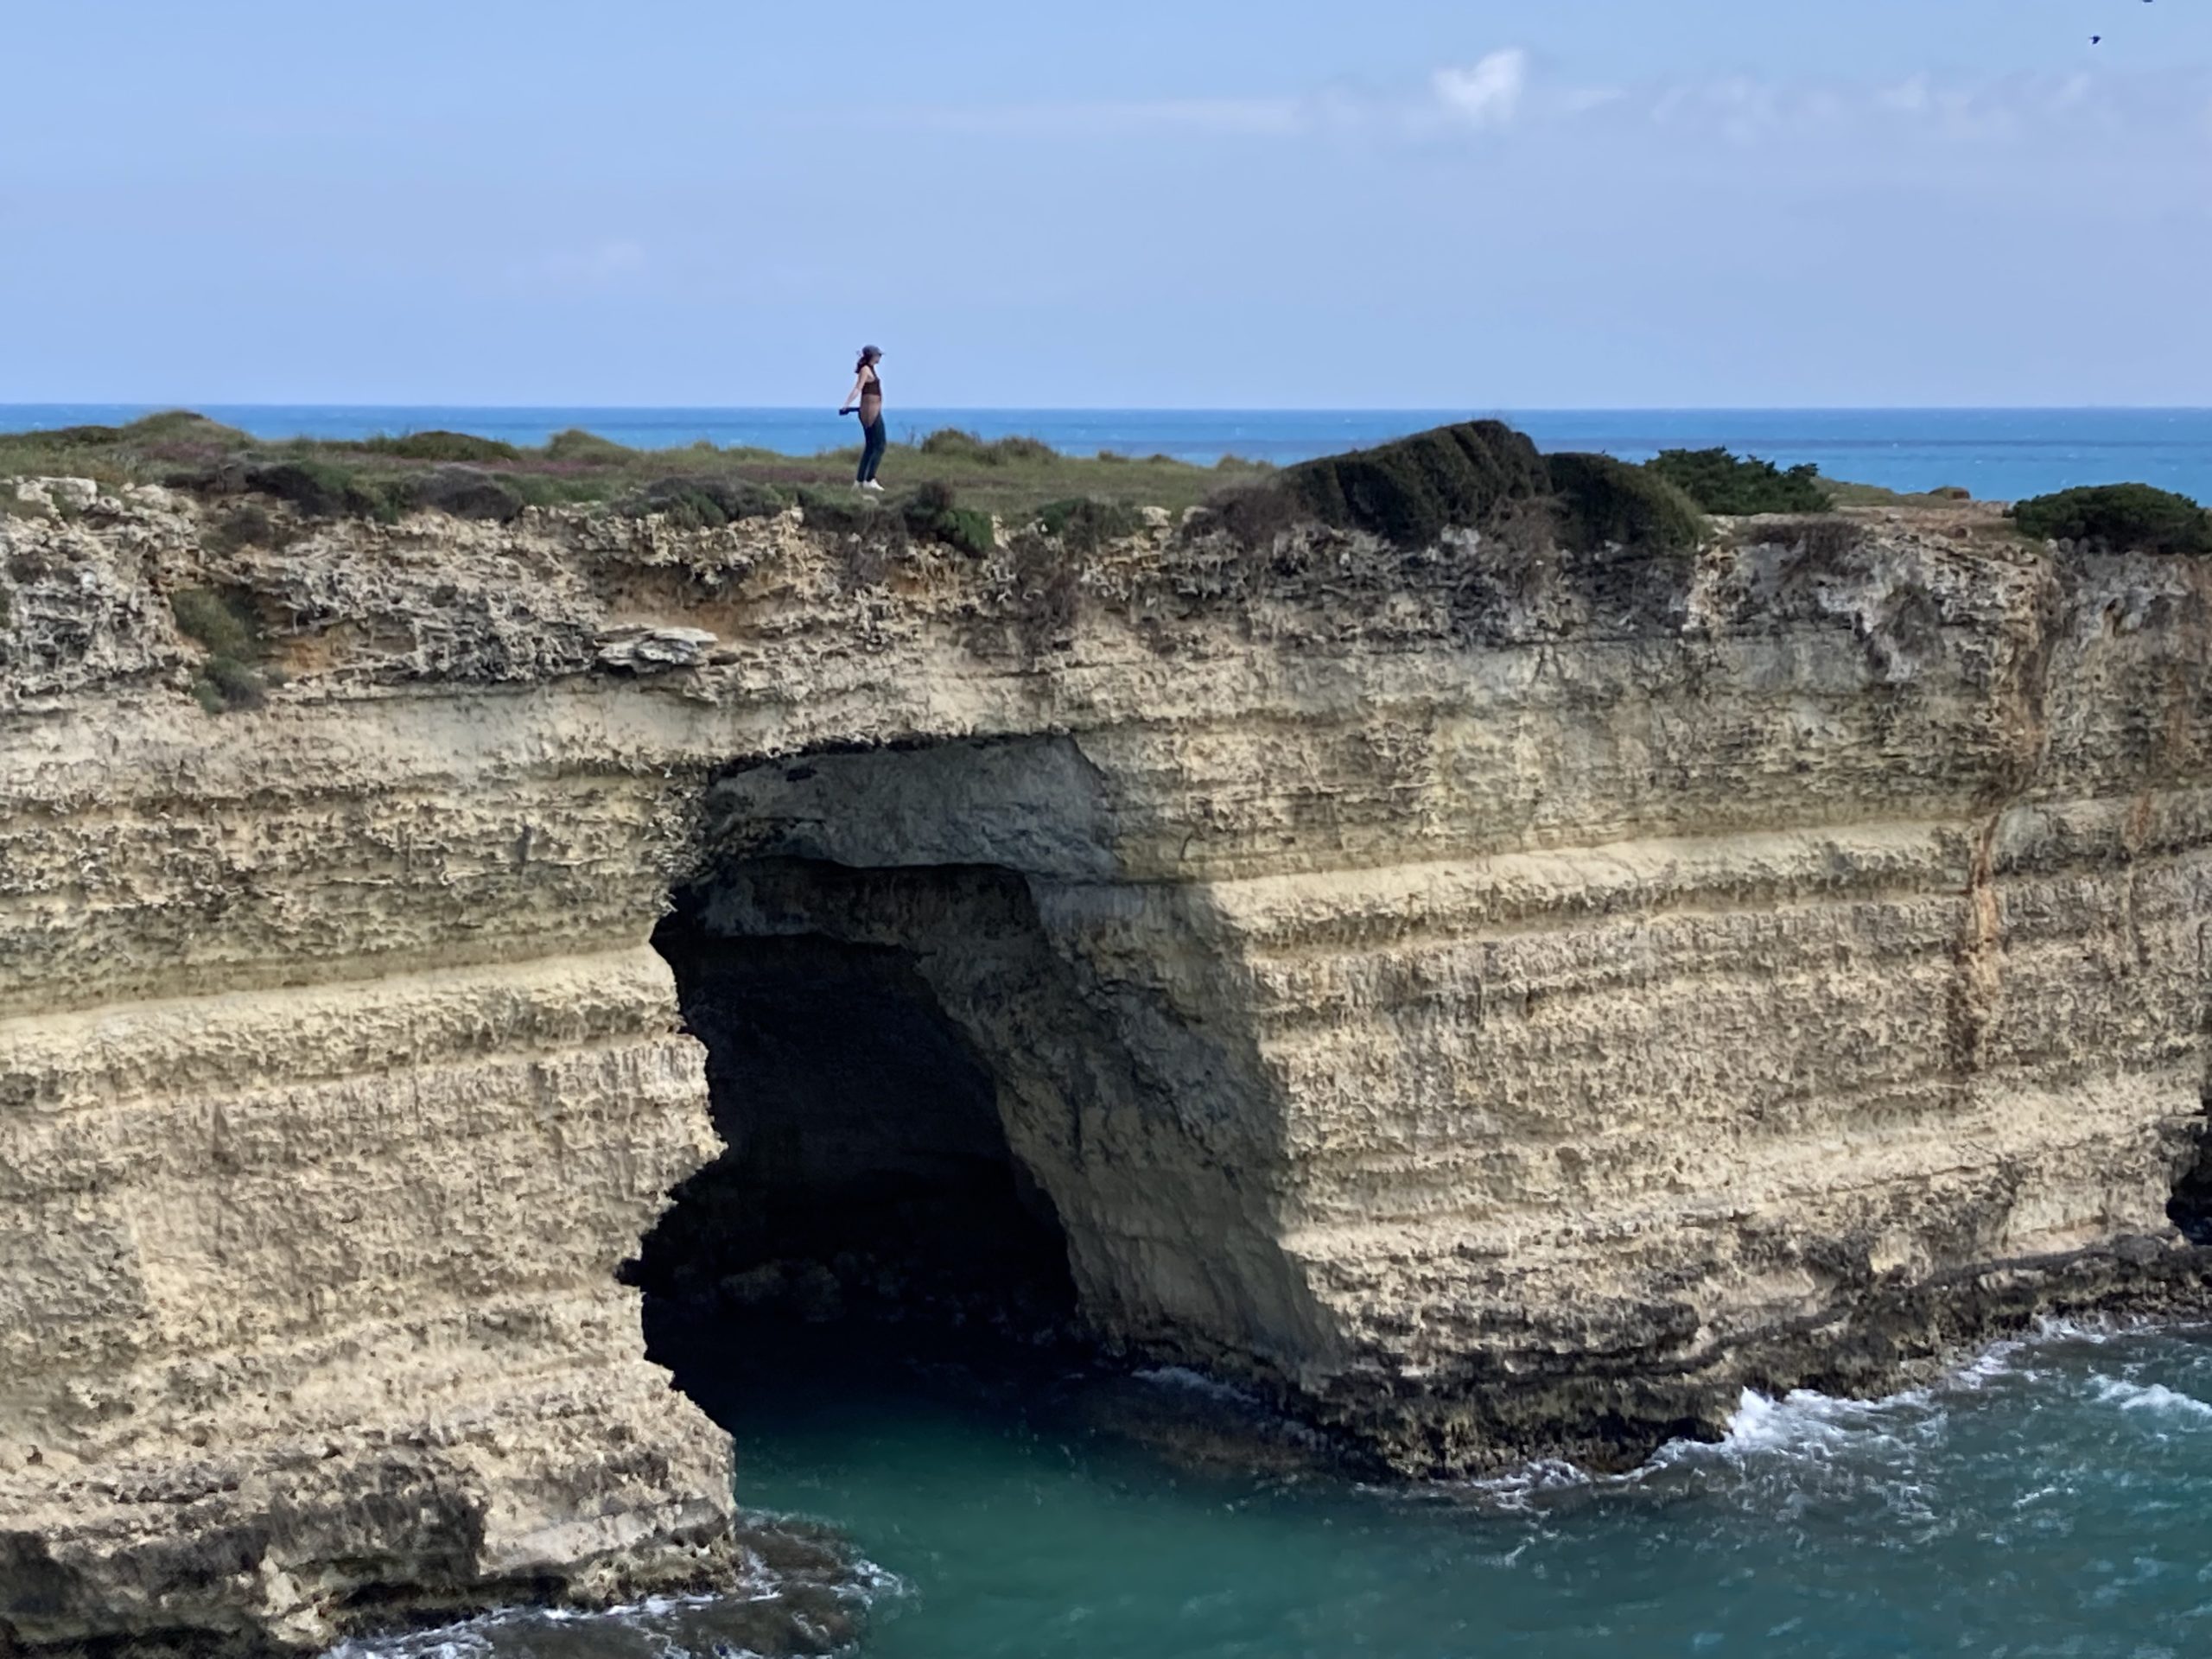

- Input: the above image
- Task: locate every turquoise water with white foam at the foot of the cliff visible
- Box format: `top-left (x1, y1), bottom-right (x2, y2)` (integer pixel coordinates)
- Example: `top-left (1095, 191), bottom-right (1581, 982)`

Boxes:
top-left (340, 1330), bottom-right (2212, 1659)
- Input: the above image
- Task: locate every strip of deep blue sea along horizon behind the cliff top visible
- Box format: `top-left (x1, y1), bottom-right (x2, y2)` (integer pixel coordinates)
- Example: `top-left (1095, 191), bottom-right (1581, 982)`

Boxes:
top-left (0, 404), bottom-right (2212, 502)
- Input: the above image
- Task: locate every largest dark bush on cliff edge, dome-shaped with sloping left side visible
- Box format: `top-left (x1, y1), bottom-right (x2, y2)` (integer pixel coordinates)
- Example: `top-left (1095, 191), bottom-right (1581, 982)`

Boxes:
top-left (1214, 420), bottom-right (1548, 546)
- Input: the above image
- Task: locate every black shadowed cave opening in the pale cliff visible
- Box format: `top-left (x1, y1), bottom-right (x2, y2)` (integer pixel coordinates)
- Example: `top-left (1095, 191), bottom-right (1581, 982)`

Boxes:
top-left (624, 861), bottom-right (1075, 1398)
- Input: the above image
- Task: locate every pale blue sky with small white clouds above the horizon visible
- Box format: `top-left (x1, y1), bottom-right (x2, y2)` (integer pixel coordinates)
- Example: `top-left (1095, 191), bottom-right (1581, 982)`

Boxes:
top-left (0, 0), bottom-right (2212, 410)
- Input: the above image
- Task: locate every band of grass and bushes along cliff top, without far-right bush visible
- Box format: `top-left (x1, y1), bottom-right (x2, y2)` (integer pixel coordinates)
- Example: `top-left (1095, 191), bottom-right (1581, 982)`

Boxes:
top-left (0, 410), bottom-right (2070, 550)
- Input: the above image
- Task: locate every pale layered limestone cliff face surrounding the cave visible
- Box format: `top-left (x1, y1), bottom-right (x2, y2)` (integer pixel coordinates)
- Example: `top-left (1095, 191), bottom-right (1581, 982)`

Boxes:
top-left (0, 489), bottom-right (2212, 1650)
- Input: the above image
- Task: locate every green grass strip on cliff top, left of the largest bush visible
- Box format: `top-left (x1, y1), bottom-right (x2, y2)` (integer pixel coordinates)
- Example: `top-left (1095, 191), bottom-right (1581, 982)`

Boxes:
top-left (0, 410), bottom-right (1269, 522)
